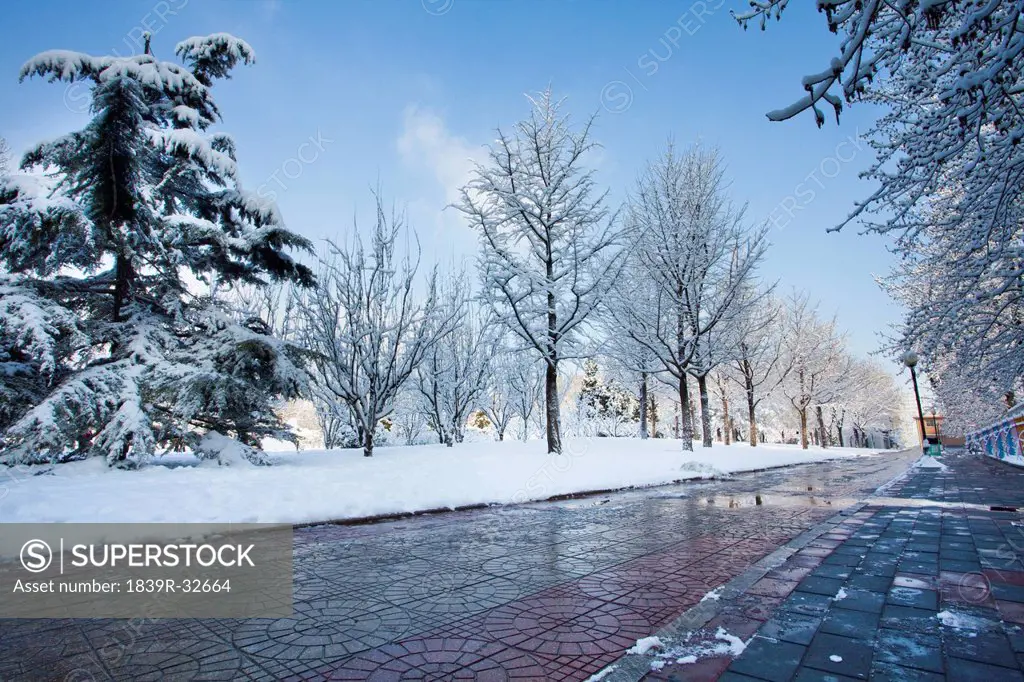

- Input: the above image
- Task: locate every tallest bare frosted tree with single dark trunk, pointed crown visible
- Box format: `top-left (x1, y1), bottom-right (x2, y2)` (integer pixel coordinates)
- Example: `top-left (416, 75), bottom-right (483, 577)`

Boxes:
top-left (458, 90), bottom-right (618, 453)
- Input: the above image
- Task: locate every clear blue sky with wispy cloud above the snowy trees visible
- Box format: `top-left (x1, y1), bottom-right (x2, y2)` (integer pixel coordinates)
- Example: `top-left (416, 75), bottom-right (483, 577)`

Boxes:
top-left (0, 0), bottom-right (900, 353)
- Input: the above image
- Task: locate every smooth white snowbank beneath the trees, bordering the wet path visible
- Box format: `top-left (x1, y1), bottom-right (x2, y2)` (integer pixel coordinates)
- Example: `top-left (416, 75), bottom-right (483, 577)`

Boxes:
top-left (0, 438), bottom-right (877, 544)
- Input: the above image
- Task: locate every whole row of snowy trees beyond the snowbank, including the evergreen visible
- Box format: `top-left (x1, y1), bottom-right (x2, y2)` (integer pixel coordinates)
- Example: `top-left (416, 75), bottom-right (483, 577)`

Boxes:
top-left (0, 34), bottom-right (897, 467)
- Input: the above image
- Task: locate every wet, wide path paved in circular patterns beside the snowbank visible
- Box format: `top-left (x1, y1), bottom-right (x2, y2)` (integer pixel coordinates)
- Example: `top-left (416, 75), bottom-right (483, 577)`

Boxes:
top-left (0, 448), bottom-right (911, 682)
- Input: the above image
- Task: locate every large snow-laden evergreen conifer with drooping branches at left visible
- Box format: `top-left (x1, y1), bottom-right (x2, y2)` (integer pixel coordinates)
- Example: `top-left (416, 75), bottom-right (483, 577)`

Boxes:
top-left (0, 34), bottom-right (312, 466)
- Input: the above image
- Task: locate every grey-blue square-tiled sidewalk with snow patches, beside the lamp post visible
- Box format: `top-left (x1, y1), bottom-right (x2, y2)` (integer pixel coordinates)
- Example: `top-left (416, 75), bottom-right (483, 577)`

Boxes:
top-left (606, 454), bottom-right (1024, 682)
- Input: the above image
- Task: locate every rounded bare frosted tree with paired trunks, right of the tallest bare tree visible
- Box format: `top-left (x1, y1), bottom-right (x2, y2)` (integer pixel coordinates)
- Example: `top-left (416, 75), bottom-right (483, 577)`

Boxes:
top-left (613, 143), bottom-right (767, 450)
